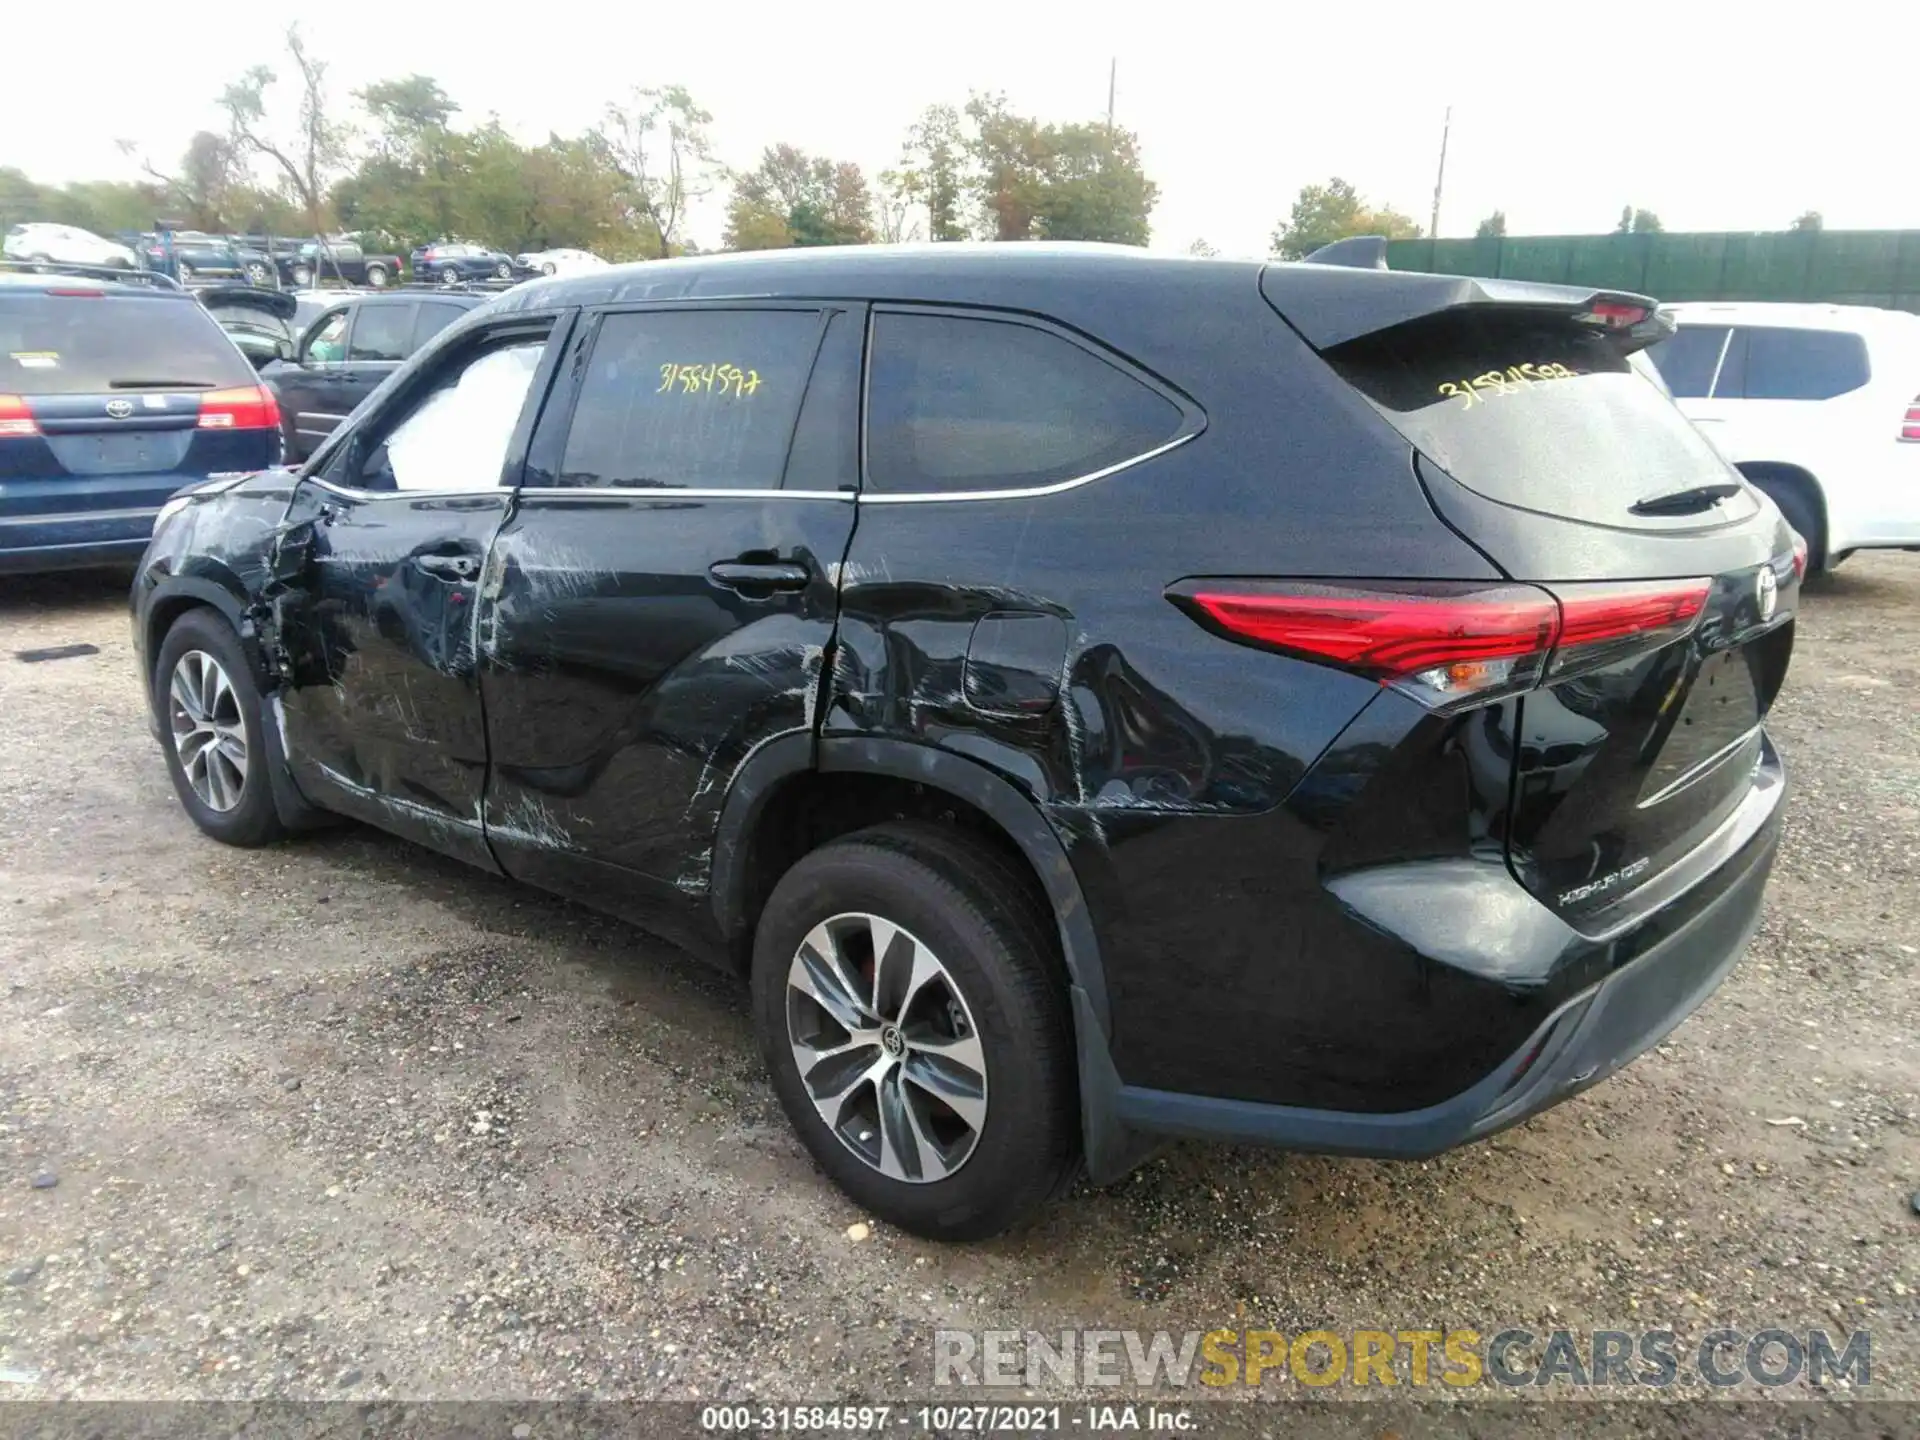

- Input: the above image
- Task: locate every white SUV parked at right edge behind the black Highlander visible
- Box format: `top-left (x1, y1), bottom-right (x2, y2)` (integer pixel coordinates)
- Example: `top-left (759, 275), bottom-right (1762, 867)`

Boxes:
top-left (1649, 301), bottom-right (1920, 570)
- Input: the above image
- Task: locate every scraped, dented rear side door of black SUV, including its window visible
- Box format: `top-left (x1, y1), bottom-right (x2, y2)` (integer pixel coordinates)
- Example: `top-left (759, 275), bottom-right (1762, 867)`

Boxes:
top-left (478, 303), bottom-right (864, 910)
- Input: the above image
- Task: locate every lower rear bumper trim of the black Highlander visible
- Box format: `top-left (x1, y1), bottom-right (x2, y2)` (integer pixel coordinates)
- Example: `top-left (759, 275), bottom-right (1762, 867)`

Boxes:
top-left (1116, 749), bottom-right (1786, 1160)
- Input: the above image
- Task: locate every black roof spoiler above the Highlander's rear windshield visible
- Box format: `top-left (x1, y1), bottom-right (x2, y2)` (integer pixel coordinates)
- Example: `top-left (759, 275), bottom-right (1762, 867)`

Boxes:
top-left (1260, 234), bottom-right (1674, 355)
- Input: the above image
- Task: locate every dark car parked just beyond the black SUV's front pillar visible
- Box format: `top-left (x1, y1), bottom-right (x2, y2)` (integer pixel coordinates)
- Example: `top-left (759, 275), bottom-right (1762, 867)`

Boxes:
top-left (261, 292), bottom-right (490, 465)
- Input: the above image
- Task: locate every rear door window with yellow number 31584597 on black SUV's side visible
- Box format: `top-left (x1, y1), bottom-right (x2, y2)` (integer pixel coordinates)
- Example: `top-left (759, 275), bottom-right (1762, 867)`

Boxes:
top-left (557, 309), bottom-right (820, 490)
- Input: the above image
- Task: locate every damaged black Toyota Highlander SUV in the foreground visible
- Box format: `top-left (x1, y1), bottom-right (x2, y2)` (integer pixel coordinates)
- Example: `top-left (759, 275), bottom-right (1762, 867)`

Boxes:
top-left (134, 246), bottom-right (1799, 1236)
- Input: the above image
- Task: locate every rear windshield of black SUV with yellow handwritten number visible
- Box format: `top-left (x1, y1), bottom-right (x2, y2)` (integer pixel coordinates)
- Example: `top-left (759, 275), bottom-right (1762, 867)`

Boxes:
top-left (1327, 309), bottom-right (1736, 528)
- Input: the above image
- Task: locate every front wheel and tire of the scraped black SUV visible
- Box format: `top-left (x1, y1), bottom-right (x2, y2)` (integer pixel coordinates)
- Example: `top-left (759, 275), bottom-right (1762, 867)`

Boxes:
top-left (154, 609), bottom-right (286, 845)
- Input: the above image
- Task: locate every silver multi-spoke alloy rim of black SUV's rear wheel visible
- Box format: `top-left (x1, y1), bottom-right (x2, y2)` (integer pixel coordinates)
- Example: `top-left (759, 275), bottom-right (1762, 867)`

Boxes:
top-left (787, 912), bottom-right (987, 1185)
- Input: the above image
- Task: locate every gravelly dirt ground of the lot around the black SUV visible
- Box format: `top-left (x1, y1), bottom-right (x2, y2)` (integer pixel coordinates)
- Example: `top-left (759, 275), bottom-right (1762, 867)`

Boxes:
top-left (0, 555), bottom-right (1920, 1400)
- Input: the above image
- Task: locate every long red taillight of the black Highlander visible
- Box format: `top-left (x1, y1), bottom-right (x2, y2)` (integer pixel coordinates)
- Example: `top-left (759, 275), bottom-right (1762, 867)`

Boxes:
top-left (1167, 580), bottom-right (1713, 710)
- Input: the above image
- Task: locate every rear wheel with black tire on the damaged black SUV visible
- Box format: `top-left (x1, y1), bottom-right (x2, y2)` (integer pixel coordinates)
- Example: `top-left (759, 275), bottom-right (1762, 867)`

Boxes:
top-left (753, 822), bottom-right (1079, 1240)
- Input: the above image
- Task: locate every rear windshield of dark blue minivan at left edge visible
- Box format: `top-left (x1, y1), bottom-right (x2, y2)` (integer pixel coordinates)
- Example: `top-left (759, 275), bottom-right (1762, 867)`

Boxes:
top-left (0, 292), bottom-right (253, 396)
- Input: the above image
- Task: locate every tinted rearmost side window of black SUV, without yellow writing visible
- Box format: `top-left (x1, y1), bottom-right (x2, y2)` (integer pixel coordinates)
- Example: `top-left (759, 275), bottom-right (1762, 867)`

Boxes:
top-left (866, 311), bottom-right (1183, 493)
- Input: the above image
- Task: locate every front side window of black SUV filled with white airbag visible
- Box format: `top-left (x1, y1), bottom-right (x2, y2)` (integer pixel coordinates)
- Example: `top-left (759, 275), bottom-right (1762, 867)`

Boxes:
top-left (355, 336), bottom-right (547, 492)
